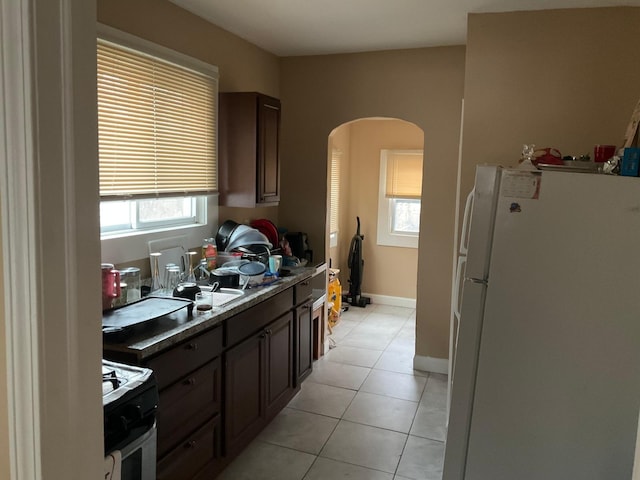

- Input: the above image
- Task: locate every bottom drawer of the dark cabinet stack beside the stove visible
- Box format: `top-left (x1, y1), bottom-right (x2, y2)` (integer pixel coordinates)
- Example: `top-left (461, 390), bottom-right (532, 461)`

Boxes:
top-left (156, 415), bottom-right (220, 480)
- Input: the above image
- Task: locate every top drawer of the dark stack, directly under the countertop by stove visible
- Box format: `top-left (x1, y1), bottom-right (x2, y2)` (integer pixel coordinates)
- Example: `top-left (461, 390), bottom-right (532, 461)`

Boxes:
top-left (147, 327), bottom-right (222, 390)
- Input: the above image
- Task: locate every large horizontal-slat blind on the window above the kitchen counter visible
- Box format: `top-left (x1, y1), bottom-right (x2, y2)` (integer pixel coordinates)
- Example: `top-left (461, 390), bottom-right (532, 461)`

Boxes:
top-left (97, 39), bottom-right (218, 200)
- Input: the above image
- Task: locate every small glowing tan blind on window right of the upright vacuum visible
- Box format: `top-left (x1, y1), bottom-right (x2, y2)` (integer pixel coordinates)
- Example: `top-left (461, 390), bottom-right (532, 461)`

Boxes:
top-left (385, 150), bottom-right (422, 199)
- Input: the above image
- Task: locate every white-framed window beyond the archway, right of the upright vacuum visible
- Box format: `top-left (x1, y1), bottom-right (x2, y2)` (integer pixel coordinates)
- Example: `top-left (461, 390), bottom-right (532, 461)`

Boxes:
top-left (378, 150), bottom-right (423, 248)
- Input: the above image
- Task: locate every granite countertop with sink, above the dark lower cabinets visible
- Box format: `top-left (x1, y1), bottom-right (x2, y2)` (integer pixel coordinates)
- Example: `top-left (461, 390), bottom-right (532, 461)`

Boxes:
top-left (103, 267), bottom-right (315, 361)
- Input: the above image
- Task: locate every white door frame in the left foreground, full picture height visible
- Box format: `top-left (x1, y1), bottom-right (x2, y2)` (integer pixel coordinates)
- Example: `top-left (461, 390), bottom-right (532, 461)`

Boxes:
top-left (0, 0), bottom-right (103, 480)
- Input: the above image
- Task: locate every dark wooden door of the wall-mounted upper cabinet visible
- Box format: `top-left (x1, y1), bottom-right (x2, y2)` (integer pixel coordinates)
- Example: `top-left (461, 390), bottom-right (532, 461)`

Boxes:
top-left (256, 95), bottom-right (280, 203)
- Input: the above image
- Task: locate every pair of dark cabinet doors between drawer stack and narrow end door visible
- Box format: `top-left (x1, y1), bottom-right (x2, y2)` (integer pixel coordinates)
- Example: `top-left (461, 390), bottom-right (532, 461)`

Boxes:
top-left (225, 312), bottom-right (295, 457)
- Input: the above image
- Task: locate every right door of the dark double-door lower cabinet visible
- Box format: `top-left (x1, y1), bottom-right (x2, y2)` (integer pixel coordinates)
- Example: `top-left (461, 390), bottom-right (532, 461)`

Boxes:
top-left (266, 312), bottom-right (294, 419)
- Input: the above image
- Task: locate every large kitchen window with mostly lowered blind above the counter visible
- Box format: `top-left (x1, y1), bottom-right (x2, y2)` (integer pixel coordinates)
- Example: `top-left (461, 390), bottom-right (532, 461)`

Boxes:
top-left (97, 26), bottom-right (218, 234)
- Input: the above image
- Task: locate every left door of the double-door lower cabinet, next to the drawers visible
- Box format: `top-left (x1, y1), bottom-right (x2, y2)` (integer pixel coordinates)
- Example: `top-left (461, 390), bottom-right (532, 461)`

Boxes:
top-left (224, 332), bottom-right (267, 456)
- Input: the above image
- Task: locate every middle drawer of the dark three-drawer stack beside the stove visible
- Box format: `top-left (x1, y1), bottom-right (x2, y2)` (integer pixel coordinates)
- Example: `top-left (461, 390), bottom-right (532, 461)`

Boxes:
top-left (157, 357), bottom-right (221, 458)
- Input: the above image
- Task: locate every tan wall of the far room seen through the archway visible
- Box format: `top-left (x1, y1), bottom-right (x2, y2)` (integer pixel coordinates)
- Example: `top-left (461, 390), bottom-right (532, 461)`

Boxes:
top-left (334, 119), bottom-right (424, 299)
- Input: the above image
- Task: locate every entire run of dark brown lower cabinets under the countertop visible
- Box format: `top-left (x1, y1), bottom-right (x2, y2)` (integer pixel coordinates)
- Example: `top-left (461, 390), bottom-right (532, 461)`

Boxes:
top-left (105, 281), bottom-right (313, 480)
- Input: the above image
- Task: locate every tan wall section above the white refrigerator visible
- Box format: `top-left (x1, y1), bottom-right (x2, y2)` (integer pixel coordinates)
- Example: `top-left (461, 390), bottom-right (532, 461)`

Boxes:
top-left (461, 8), bottom-right (640, 214)
